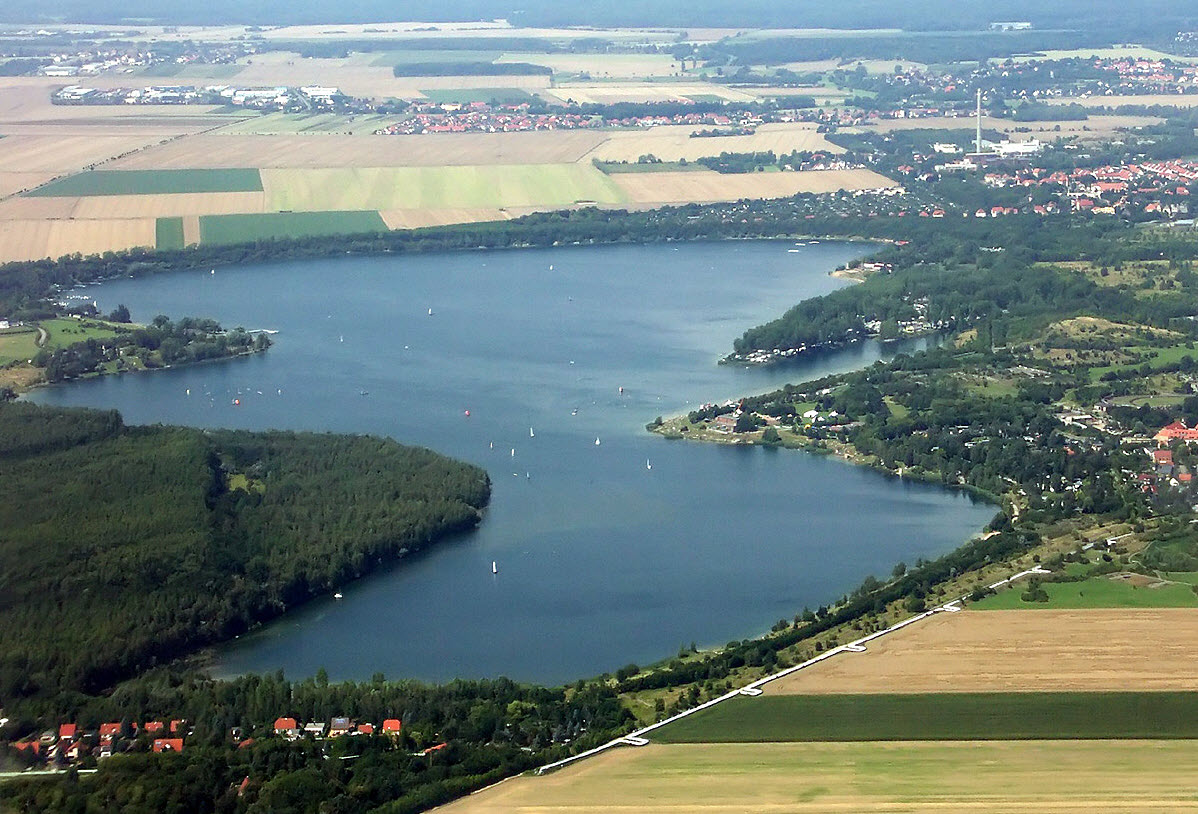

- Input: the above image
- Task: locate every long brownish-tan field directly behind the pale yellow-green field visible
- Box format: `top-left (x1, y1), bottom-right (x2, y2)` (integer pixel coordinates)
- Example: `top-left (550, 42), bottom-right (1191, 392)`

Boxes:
top-left (111, 131), bottom-right (608, 169)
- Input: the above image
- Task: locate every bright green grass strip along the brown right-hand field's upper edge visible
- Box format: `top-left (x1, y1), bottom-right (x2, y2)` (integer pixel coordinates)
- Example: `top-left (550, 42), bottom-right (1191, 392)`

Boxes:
top-left (972, 575), bottom-right (1198, 610)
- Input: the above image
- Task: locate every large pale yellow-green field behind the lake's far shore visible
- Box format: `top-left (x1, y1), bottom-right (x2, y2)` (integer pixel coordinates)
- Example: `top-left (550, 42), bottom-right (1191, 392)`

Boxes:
top-left (262, 164), bottom-right (627, 212)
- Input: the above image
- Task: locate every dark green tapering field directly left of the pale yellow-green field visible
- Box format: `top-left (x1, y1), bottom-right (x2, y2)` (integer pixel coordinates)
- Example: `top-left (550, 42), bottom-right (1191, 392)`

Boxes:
top-left (25, 169), bottom-right (262, 198)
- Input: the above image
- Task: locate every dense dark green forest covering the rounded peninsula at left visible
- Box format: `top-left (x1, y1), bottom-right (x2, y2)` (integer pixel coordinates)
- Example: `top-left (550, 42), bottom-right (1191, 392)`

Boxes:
top-left (0, 403), bottom-right (490, 711)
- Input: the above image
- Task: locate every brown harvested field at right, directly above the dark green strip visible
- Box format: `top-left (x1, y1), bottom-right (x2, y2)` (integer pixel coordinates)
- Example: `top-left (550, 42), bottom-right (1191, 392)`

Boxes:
top-left (766, 609), bottom-right (1198, 695)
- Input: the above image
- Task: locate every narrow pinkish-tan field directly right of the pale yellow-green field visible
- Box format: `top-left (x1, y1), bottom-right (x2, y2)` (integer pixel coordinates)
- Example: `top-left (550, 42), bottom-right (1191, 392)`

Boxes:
top-left (612, 169), bottom-right (895, 204)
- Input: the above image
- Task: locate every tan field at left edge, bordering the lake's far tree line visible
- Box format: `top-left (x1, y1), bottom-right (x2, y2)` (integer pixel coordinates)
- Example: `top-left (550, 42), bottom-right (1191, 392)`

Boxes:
top-left (0, 218), bottom-right (156, 263)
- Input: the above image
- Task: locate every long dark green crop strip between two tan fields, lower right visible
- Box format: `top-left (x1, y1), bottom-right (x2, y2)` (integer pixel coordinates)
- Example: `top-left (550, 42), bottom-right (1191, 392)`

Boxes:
top-left (652, 692), bottom-right (1198, 743)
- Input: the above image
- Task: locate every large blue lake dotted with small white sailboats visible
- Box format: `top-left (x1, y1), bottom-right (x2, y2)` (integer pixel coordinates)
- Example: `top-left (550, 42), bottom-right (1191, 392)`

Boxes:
top-left (31, 241), bottom-right (996, 683)
